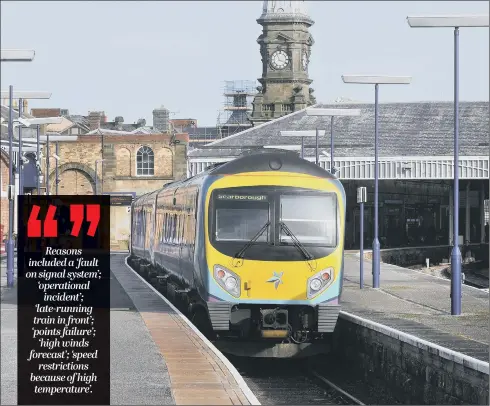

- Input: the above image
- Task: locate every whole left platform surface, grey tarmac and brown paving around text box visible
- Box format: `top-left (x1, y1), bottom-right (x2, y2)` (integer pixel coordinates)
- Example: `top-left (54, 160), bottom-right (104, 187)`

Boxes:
top-left (1, 254), bottom-right (250, 405)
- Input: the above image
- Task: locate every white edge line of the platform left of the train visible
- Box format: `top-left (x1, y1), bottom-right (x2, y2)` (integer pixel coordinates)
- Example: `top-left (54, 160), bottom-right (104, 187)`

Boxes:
top-left (124, 255), bottom-right (261, 406)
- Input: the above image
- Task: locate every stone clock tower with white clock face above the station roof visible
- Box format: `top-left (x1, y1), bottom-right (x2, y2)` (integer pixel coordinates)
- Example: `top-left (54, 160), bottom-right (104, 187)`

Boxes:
top-left (249, 0), bottom-right (315, 125)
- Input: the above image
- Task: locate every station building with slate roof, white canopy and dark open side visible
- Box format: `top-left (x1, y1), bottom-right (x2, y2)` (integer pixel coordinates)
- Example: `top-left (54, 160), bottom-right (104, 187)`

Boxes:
top-left (188, 102), bottom-right (489, 248)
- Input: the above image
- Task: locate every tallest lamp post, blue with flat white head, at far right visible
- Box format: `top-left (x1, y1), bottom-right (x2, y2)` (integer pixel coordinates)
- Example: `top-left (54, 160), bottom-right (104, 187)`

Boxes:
top-left (407, 14), bottom-right (489, 316)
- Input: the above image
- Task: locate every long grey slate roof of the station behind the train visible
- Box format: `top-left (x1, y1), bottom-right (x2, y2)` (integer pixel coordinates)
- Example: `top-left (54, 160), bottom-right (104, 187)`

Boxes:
top-left (189, 102), bottom-right (489, 158)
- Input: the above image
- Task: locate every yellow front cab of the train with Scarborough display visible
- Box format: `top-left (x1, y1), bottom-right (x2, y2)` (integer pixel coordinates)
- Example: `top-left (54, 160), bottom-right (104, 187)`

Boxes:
top-left (205, 172), bottom-right (345, 357)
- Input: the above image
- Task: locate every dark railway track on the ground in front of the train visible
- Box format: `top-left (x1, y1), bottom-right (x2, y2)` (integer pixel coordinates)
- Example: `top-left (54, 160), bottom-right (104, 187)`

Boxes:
top-left (228, 356), bottom-right (364, 405)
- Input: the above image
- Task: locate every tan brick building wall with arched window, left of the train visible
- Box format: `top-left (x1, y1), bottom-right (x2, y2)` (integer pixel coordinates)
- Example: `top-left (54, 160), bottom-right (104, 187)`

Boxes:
top-left (43, 129), bottom-right (188, 249)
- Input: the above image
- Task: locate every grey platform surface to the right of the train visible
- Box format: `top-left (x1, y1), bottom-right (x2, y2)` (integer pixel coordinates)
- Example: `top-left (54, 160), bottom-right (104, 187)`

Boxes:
top-left (341, 253), bottom-right (490, 362)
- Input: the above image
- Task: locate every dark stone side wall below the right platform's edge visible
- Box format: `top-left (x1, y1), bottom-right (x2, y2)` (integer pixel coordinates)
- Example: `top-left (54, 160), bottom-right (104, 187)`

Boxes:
top-left (333, 313), bottom-right (489, 405)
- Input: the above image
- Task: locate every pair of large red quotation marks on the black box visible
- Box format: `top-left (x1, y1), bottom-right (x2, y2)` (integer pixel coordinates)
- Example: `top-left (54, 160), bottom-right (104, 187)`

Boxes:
top-left (27, 204), bottom-right (100, 237)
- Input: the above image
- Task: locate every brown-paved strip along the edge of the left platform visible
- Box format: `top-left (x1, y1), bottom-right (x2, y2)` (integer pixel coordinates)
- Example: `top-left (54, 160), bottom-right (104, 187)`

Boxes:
top-left (111, 254), bottom-right (250, 405)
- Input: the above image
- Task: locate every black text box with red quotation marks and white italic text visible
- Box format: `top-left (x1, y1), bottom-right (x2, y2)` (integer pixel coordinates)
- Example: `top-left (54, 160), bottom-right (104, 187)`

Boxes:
top-left (17, 196), bottom-right (110, 405)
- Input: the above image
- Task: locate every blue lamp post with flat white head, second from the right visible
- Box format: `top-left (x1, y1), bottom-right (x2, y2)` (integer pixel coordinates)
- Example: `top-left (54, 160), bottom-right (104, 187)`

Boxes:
top-left (342, 75), bottom-right (412, 289)
